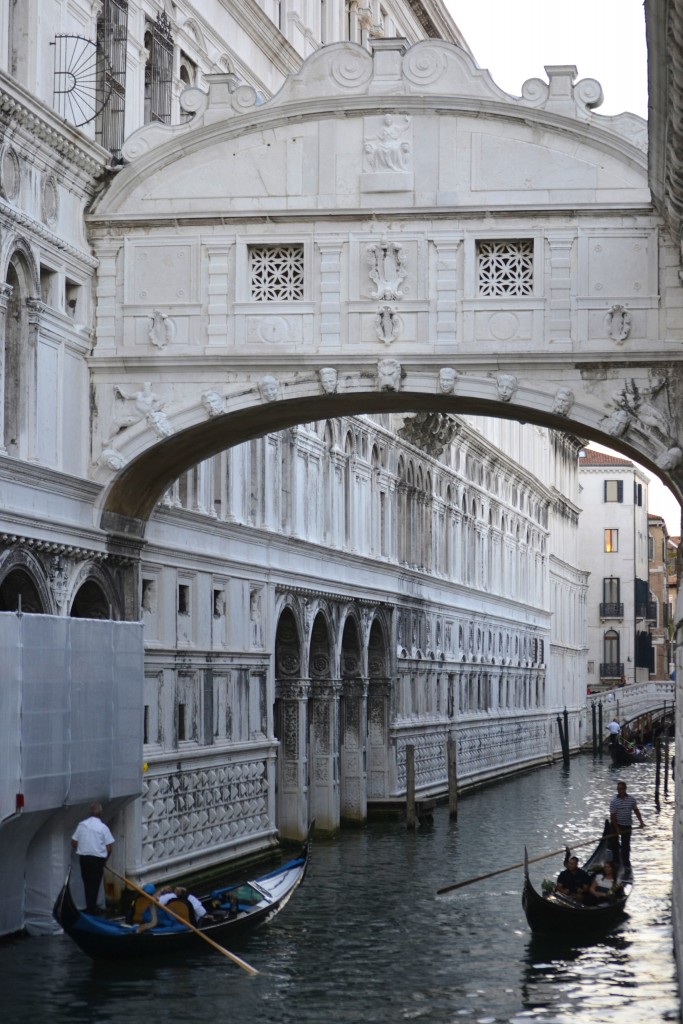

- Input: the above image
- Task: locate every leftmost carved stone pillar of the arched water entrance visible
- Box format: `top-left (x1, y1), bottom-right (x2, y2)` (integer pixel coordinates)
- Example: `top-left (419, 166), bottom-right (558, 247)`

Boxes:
top-left (274, 679), bottom-right (312, 840)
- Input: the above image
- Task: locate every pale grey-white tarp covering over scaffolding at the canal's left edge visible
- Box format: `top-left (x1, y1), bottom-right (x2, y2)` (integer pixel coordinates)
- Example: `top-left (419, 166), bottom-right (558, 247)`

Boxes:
top-left (0, 612), bottom-right (143, 935)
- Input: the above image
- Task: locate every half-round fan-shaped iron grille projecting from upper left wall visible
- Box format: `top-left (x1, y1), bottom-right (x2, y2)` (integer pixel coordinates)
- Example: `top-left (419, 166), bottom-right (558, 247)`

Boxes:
top-left (52, 36), bottom-right (112, 128)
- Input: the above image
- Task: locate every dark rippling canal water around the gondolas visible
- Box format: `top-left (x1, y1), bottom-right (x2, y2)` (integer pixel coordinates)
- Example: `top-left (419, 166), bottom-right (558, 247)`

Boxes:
top-left (0, 755), bottom-right (680, 1024)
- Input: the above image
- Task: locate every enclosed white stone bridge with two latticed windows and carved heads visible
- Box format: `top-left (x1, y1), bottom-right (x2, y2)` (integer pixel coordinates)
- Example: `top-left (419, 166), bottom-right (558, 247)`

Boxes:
top-left (83, 39), bottom-right (683, 536)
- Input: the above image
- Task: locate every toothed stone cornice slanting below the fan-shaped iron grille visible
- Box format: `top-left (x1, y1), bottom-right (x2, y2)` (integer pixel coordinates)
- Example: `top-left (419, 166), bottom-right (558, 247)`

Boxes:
top-left (0, 71), bottom-right (110, 178)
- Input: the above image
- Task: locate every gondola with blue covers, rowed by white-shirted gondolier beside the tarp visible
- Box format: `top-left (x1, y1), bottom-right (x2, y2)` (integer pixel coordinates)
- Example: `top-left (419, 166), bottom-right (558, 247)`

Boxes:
top-left (52, 834), bottom-right (310, 961)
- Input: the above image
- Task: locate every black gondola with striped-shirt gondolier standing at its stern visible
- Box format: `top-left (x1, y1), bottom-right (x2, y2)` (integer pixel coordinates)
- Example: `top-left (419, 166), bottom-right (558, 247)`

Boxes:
top-left (522, 819), bottom-right (633, 936)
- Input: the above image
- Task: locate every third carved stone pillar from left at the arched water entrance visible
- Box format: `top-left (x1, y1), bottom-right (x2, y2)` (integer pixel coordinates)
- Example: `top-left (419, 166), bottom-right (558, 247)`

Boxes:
top-left (340, 679), bottom-right (368, 821)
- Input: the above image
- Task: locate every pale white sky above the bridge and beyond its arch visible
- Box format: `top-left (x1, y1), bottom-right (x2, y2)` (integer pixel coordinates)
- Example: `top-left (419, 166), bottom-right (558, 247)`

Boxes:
top-left (445, 0), bottom-right (681, 536)
